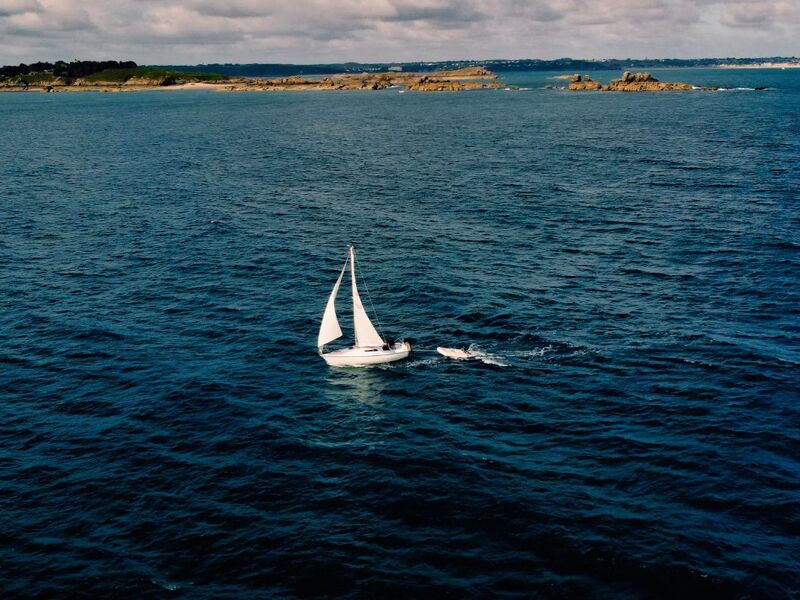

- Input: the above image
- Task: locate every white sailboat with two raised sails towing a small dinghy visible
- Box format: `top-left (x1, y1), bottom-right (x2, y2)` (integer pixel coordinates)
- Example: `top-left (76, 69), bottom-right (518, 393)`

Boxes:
top-left (317, 245), bottom-right (411, 367)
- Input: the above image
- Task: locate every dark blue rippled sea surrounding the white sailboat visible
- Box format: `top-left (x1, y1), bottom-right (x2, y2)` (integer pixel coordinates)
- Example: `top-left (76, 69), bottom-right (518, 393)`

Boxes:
top-left (0, 70), bottom-right (800, 599)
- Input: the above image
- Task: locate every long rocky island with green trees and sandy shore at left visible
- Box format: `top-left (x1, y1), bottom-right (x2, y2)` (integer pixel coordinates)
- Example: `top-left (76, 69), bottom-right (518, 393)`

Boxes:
top-left (0, 61), bottom-right (505, 92)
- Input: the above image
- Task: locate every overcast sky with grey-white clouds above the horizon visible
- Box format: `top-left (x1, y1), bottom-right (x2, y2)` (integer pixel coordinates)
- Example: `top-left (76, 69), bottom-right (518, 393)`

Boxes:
top-left (0, 0), bottom-right (800, 64)
